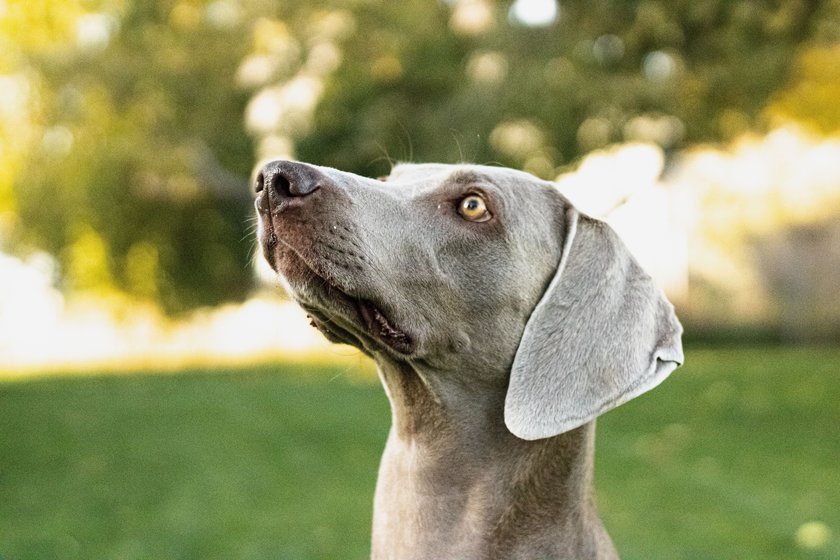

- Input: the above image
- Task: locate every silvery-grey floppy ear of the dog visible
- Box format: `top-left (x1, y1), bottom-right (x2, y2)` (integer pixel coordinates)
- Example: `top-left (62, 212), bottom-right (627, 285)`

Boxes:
top-left (505, 199), bottom-right (683, 440)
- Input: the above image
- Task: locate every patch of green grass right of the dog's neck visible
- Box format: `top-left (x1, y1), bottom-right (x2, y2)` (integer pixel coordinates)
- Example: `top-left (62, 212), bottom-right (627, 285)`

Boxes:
top-left (597, 348), bottom-right (840, 560)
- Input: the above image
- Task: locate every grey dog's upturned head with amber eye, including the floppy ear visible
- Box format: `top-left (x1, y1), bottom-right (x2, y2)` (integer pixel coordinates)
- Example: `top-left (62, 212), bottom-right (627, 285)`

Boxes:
top-left (256, 161), bottom-right (683, 439)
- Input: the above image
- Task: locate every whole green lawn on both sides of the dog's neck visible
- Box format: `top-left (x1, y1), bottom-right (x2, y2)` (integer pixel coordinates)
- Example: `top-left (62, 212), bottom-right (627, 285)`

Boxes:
top-left (0, 348), bottom-right (840, 560)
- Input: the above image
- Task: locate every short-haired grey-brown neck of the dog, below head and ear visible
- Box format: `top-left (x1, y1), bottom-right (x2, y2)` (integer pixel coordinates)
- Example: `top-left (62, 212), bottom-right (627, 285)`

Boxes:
top-left (373, 362), bottom-right (609, 560)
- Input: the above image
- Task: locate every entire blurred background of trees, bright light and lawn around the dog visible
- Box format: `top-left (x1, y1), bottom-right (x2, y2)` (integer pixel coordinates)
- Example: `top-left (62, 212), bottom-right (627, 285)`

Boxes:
top-left (0, 0), bottom-right (840, 560)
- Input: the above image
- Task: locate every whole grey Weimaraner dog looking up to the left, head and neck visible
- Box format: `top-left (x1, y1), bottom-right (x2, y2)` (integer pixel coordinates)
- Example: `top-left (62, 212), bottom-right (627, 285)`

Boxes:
top-left (256, 161), bottom-right (683, 560)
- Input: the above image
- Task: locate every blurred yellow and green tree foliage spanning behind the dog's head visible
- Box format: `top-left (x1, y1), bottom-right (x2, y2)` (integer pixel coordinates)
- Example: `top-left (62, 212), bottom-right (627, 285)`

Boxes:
top-left (0, 0), bottom-right (840, 311)
